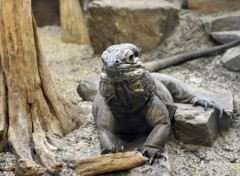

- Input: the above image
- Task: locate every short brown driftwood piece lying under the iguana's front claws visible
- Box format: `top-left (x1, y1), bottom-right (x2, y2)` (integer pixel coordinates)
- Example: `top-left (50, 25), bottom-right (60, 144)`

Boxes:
top-left (71, 151), bottom-right (147, 176)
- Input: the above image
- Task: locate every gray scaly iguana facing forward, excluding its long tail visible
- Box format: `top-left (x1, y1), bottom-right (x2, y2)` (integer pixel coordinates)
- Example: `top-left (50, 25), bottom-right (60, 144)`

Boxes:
top-left (93, 43), bottom-right (227, 164)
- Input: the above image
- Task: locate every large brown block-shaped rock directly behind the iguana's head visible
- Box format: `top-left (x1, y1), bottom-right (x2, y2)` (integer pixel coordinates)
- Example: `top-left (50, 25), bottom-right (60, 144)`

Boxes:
top-left (88, 0), bottom-right (179, 53)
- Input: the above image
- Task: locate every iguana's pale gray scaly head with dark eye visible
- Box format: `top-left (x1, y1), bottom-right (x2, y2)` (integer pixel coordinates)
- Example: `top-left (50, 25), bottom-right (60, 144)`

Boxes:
top-left (102, 43), bottom-right (144, 78)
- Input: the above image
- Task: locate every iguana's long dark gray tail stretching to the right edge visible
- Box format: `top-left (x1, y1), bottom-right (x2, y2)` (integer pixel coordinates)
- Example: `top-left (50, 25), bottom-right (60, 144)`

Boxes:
top-left (144, 39), bottom-right (240, 72)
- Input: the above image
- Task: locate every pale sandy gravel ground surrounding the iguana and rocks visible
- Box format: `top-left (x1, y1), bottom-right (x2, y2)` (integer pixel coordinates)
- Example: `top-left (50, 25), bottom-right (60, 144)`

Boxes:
top-left (0, 10), bottom-right (240, 176)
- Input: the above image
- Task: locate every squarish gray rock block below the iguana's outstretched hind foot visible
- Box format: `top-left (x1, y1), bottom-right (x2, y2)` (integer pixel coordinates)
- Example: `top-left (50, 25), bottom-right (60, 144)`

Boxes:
top-left (174, 104), bottom-right (218, 146)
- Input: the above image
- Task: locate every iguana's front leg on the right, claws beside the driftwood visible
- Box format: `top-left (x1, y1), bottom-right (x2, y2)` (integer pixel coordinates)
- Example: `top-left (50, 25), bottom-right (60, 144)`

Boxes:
top-left (142, 96), bottom-right (170, 164)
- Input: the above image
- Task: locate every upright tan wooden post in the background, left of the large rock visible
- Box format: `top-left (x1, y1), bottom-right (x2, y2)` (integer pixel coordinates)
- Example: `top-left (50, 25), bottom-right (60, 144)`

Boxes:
top-left (60, 0), bottom-right (91, 44)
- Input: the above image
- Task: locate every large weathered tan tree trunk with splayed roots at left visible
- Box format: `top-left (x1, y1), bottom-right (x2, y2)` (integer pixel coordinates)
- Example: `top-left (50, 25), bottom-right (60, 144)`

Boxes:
top-left (0, 0), bottom-right (82, 176)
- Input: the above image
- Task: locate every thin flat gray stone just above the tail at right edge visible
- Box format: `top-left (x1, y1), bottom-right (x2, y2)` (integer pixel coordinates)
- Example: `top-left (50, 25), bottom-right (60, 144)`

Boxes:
top-left (212, 30), bottom-right (240, 43)
